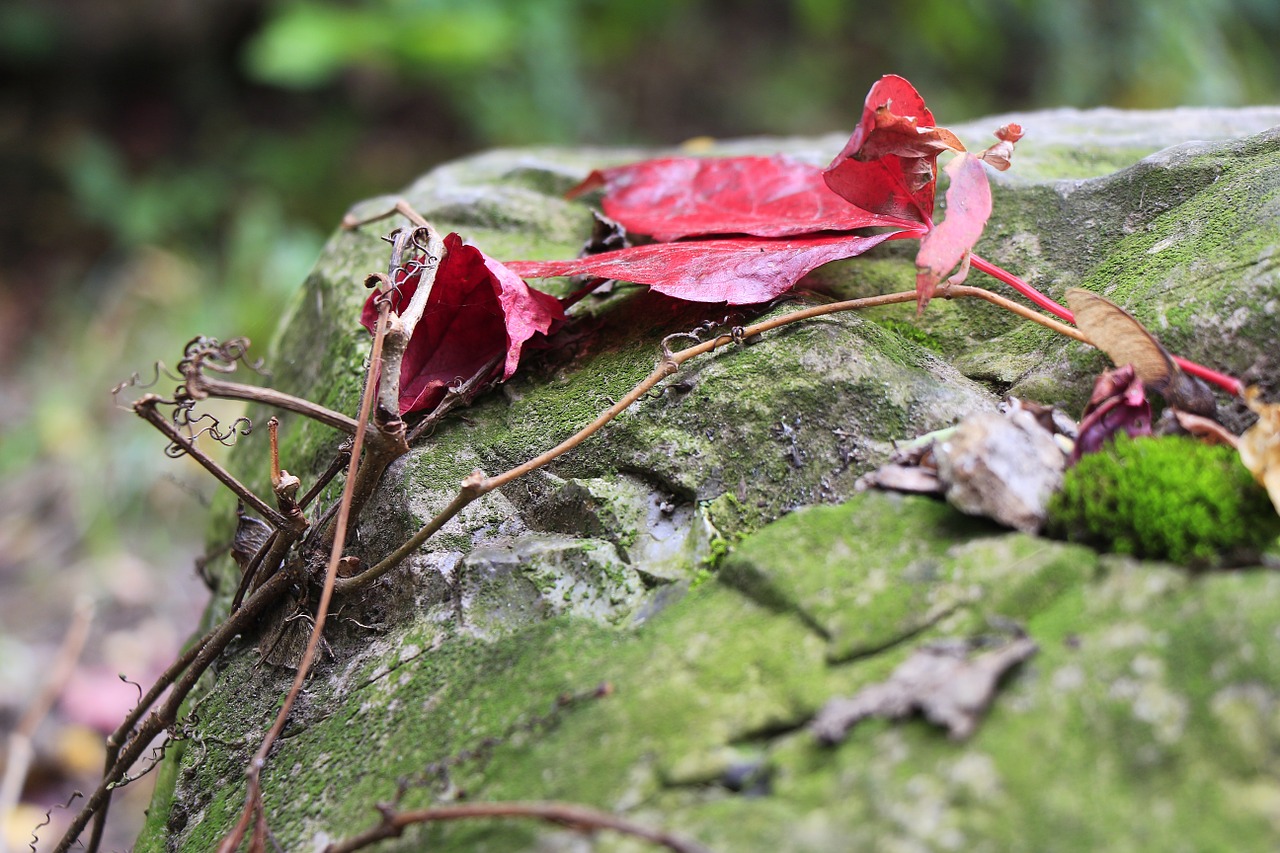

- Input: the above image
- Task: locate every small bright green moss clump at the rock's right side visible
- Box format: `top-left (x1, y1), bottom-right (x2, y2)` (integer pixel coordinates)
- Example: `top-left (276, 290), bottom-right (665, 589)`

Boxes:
top-left (1048, 434), bottom-right (1280, 566)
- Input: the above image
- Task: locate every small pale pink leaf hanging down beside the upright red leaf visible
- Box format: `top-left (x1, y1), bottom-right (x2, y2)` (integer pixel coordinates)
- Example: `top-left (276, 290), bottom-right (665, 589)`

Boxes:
top-left (915, 154), bottom-right (991, 311)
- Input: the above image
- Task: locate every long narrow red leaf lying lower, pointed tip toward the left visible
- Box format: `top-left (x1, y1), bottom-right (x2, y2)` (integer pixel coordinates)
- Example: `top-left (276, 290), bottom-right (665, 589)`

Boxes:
top-left (507, 232), bottom-right (901, 305)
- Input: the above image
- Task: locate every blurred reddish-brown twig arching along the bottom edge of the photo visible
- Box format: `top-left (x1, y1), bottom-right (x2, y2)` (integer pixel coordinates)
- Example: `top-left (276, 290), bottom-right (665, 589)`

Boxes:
top-left (324, 803), bottom-right (708, 853)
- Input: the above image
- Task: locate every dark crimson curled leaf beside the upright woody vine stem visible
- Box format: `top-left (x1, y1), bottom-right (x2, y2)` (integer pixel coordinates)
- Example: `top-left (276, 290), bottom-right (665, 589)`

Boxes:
top-left (360, 234), bottom-right (564, 415)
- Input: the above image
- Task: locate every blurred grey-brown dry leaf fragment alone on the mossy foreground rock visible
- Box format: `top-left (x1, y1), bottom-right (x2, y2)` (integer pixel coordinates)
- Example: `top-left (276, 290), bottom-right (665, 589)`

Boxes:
top-left (810, 637), bottom-right (1038, 743)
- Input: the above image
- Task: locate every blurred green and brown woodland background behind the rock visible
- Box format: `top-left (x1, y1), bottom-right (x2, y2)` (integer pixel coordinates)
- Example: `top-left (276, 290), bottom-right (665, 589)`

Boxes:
top-left (0, 0), bottom-right (1280, 849)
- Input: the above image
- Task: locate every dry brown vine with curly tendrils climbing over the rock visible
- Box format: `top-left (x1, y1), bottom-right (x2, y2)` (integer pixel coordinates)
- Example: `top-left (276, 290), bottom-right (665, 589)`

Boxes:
top-left (55, 195), bottom-right (1162, 853)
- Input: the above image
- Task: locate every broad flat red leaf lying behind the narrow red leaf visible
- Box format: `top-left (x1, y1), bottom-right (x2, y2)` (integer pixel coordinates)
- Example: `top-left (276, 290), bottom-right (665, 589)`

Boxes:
top-left (570, 156), bottom-right (913, 242)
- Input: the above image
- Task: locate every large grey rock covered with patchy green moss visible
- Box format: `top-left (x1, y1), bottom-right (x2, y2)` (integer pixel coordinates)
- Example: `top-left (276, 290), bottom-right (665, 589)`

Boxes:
top-left (138, 109), bottom-right (1280, 852)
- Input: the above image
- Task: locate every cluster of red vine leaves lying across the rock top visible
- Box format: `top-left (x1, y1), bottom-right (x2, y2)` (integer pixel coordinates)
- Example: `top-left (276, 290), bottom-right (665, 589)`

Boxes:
top-left (362, 76), bottom-right (1020, 414)
